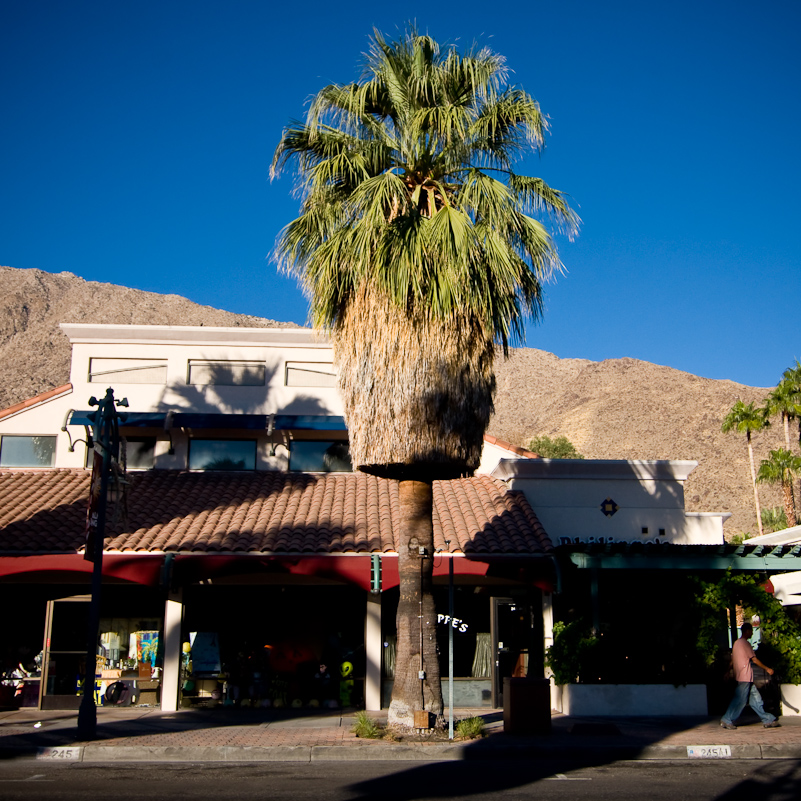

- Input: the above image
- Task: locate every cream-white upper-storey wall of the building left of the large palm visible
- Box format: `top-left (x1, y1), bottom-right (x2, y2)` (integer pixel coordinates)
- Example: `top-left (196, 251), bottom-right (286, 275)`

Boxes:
top-left (0, 324), bottom-right (343, 470)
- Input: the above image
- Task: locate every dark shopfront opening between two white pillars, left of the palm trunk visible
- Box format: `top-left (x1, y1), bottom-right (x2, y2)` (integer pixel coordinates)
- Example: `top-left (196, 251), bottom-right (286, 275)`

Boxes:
top-left (181, 585), bottom-right (365, 709)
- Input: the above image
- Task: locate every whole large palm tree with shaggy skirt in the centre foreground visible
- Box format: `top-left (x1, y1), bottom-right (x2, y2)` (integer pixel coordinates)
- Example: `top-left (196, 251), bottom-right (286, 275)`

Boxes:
top-left (272, 29), bottom-right (579, 726)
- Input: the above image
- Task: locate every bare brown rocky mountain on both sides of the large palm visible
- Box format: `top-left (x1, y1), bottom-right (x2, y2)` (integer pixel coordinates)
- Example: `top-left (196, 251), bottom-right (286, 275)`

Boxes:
top-left (0, 267), bottom-right (783, 535)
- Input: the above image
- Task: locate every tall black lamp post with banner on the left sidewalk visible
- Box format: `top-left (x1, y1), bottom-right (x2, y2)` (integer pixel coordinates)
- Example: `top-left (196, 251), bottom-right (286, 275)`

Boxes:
top-left (78, 387), bottom-right (128, 740)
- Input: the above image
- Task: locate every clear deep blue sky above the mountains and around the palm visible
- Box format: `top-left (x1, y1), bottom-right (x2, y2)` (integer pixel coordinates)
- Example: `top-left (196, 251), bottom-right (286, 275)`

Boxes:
top-left (0, 0), bottom-right (801, 386)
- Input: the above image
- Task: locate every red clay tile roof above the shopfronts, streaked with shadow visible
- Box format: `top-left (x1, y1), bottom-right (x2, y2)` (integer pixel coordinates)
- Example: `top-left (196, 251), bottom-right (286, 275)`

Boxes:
top-left (0, 470), bottom-right (553, 555)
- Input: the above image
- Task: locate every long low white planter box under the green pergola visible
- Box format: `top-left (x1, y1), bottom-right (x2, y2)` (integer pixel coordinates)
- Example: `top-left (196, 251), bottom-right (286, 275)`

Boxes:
top-left (551, 684), bottom-right (708, 717)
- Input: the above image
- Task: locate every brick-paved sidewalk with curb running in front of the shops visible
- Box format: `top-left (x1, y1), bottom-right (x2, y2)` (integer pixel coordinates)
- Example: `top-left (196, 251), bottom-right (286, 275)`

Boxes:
top-left (0, 708), bottom-right (801, 763)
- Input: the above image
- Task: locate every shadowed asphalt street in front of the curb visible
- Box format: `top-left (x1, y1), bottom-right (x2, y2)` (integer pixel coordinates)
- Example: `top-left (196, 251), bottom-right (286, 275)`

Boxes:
top-left (0, 759), bottom-right (801, 801)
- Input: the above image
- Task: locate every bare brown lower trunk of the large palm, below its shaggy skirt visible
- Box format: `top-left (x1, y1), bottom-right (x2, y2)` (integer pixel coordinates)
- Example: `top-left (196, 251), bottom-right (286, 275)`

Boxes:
top-left (388, 481), bottom-right (442, 728)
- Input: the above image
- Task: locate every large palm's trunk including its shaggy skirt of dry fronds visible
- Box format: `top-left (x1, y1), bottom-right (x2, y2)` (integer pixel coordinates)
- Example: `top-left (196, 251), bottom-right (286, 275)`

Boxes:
top-left (332, 286), bottom-right (495, 727)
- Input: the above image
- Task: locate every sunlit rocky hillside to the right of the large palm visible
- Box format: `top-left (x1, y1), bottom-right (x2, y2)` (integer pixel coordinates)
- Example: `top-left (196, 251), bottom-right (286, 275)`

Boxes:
top-left (491, 348), bottom-right (784, 535)
